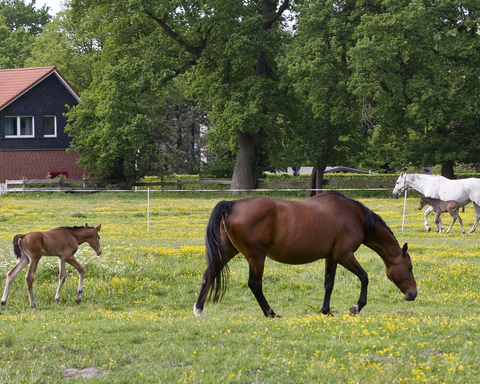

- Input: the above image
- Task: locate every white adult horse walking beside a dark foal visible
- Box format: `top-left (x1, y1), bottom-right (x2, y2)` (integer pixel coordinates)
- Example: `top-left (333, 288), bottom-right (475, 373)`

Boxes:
top-left (393, 173), bottom-right (480, 233)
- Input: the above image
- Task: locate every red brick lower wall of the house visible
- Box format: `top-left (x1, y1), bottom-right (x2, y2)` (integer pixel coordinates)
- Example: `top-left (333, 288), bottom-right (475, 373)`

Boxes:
top-left (0, 150), bottom-right (88, 183)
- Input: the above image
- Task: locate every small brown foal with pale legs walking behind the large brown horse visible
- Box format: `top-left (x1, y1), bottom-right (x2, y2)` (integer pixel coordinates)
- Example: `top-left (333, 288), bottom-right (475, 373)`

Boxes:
top-left (1, 224), bottom-right (102, 310)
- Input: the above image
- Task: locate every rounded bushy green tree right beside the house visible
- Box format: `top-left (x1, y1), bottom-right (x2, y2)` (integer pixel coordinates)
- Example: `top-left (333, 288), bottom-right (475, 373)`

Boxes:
top-left (66, 3), bottom-right (209, 187)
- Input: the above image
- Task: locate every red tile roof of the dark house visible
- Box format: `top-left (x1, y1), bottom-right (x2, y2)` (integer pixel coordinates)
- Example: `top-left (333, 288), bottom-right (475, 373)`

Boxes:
top-left (0, 67), bottom-right (80, 110)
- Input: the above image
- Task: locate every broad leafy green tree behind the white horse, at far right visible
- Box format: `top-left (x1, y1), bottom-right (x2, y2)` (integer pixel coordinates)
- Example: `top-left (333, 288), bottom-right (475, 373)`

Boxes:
top-left (349, 0), bottom-right (480, 178)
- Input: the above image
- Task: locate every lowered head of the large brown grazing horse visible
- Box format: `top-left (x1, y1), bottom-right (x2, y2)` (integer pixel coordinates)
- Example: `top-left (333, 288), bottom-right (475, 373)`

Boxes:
top-left (387, 243), bottom-right (417, 301)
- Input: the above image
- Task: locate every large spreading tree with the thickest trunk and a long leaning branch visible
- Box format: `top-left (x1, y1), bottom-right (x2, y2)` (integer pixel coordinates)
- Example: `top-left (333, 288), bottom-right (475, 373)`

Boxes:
top-left (67, 0), bottom-right (289, 189)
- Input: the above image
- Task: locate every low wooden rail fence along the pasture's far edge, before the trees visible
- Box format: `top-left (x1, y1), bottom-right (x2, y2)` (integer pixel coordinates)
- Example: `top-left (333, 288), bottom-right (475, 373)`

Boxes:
top-left (0, 178), bottom-right (395, 193)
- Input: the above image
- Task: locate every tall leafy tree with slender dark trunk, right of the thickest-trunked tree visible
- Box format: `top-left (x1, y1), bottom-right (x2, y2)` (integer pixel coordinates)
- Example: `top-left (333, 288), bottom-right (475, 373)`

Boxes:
top-left (284, 0), bottom-right (365, 194)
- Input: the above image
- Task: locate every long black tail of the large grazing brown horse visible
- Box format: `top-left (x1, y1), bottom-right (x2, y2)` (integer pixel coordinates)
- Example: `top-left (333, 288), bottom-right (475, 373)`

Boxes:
top-left (202, 201), bottom-right (232, 302)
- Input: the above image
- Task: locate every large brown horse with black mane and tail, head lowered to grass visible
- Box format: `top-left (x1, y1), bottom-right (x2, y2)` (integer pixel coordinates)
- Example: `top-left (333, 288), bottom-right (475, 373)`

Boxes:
top-left (193, 192), bottom-right (417, 317)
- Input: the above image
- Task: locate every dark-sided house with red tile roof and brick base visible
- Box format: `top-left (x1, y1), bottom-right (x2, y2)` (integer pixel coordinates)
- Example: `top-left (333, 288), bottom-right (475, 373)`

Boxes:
top-left (0, 67), bottom-right (86, 183)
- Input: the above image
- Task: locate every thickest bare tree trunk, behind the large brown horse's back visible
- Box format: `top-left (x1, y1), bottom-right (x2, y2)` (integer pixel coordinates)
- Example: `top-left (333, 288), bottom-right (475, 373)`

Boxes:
top-left (230, 132), bottom-right (263, 190)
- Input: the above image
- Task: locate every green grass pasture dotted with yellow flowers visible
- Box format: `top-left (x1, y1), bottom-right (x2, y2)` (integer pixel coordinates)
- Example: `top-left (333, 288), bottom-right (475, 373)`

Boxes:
top-left (0, 193), bottom-right (480, 384)
